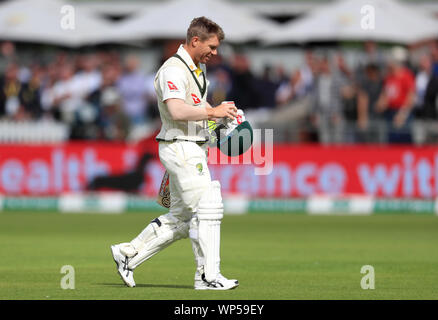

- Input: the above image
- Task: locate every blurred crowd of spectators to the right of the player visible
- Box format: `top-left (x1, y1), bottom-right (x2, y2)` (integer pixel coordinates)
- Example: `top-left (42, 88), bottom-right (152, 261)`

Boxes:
top-left (210, 42), bottom-right (438, 143)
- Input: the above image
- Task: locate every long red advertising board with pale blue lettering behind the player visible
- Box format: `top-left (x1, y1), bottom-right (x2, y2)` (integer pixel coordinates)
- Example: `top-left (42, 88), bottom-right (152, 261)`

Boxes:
top-left (0, 142), bottom-right (438, 198)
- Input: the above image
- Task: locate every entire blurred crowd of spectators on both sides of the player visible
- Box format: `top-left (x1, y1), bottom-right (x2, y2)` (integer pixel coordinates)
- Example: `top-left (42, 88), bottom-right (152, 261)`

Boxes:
top-left (0, 42), bottom-right (438, 143)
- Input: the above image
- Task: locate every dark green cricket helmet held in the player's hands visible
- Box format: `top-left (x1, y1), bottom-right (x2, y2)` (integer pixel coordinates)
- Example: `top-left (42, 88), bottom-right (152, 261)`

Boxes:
top-left (214, 120), bottom-right (253, 157)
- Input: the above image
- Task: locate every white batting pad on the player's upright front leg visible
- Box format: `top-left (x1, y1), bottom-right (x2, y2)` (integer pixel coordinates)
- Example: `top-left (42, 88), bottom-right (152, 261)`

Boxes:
top-left (198, 181), bottom-right (224, 281)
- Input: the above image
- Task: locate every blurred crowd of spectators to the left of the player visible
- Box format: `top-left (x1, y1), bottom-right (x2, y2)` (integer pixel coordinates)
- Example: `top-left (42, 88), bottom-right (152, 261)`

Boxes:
top-left (0, 40), bottom-right (156, 141)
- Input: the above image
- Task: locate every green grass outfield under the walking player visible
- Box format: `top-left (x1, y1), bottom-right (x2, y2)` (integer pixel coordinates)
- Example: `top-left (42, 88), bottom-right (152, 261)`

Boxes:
top-left (0, 212), bottom-right (438, 300)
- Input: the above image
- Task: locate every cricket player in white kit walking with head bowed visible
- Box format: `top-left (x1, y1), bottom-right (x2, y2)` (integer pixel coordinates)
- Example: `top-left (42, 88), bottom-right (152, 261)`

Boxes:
top-left (111, 17), bottom-right (239, 290)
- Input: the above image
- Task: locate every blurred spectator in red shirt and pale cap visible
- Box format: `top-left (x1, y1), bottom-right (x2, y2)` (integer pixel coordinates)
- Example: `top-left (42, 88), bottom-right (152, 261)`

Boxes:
top-left (376, 47), bottom-right (415, 143)
